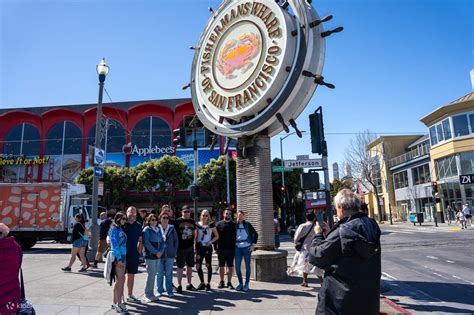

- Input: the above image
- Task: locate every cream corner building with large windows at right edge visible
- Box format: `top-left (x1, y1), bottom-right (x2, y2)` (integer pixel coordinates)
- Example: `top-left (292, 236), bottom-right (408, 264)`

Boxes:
top-left (421, 93), bottom-right (474, 217)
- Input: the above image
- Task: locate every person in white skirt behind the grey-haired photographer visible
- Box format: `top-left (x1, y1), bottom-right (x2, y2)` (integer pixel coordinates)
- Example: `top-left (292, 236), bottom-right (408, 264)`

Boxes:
top-left (287, 211), bottom-right (323, 287)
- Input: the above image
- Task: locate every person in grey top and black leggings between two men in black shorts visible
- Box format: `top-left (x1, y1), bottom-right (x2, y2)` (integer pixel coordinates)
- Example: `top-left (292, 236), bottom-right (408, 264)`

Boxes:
top-left (196, 210), bottom-right (219, 291)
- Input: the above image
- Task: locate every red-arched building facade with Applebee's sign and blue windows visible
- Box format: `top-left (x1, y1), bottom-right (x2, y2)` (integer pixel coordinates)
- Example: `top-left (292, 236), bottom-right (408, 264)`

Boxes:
top-left (0, 99), bottom-right (223, 182)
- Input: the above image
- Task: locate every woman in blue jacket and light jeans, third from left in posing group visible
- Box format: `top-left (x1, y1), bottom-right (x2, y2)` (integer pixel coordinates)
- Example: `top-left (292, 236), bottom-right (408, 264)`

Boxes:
top-left (143, 213), bottom-right (164, 303)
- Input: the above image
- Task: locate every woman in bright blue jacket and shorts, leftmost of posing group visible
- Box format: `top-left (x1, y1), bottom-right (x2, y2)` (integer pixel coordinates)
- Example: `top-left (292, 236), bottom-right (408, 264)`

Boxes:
top-left (108, 212), bottom-right (128, 313)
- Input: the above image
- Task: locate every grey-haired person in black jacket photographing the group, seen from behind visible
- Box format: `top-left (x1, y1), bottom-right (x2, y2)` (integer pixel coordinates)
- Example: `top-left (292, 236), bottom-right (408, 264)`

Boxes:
top-left (309, 189), bottom-right (381, 315)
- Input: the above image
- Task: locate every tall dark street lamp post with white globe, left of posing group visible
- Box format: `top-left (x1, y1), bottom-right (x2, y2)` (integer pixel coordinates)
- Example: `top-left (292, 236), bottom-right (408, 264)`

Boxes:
top-left (89, 58), bottom-right (109, 259)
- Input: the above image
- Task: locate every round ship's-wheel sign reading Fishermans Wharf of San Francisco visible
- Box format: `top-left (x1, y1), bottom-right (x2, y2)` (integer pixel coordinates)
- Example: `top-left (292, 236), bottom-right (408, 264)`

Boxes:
top-left (188, 0), bottom-right (343, 138)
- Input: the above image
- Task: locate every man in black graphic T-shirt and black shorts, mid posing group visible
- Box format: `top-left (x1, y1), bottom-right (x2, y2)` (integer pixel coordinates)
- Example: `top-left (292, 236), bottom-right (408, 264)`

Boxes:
top-left (174, 205), bottom-right (196, 294)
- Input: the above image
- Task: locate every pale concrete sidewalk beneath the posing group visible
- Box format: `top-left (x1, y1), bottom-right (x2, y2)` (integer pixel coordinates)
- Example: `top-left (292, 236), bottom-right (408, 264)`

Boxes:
top-left (23, 243), bottom-right (408, 315)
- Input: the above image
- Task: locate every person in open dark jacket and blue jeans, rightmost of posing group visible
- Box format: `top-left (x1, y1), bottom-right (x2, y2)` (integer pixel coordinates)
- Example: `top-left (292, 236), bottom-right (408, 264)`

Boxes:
top-left (235, 210), bottom-right (258, 292)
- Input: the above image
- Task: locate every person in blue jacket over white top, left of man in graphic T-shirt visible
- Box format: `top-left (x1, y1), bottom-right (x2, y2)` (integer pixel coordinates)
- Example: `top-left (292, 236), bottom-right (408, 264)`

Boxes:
top-left (156, 211), bottom-right (178, 297)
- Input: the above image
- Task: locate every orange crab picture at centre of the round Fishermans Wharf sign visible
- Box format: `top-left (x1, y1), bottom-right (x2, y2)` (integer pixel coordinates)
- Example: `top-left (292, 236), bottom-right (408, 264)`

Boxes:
top-left (217, 33), bottom-right (261, 79)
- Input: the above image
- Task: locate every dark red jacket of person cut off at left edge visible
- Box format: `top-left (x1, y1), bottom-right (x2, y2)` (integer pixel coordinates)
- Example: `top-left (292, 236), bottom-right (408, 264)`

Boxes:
top-left (0, 236), bottom-right (23, 315)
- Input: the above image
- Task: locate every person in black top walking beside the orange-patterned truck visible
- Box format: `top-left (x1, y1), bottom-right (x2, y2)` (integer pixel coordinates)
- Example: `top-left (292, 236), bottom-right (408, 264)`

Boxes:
top-left (61, 213), bottom-right (89, 272)
